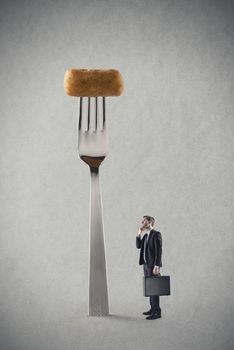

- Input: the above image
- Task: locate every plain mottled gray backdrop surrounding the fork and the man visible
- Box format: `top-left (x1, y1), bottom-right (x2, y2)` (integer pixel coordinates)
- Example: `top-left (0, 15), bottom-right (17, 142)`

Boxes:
top-left (0, 0), bottom-right (234, 350)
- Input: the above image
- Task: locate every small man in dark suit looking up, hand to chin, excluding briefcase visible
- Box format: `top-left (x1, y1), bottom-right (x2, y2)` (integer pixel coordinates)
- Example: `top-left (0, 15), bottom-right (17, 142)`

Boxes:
top-left (136, 215), bottom-right (162, 320)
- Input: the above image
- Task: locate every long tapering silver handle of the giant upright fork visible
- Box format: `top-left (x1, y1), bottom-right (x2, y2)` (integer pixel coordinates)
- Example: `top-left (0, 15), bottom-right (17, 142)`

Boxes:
top-left (89, 167), bottom-right (109, 316)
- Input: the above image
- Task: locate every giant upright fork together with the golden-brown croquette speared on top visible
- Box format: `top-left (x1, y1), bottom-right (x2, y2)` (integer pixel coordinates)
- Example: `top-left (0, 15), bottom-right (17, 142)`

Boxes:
top-left (64, 68), bottom-right (123, 316)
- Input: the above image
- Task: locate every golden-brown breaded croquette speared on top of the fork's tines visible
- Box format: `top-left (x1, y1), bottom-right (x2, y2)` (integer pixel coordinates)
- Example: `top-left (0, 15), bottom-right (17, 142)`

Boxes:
top-left (64, 69), bottom-right (123, 97)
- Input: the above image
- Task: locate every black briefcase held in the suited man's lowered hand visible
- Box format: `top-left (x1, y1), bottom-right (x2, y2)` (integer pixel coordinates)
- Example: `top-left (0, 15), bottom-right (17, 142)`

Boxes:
top-left (143, 275), bottom-right (171, 297)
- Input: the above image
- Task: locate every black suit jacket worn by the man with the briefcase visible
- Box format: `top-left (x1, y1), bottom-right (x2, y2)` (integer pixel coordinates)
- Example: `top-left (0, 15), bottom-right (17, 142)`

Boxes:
top-left (136, 229), bottom-right (162, 267)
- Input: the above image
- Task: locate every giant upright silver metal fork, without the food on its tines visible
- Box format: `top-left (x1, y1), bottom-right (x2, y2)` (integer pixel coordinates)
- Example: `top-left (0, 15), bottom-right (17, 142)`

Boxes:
top-left (78, 97), bottom-right (109, 316)
